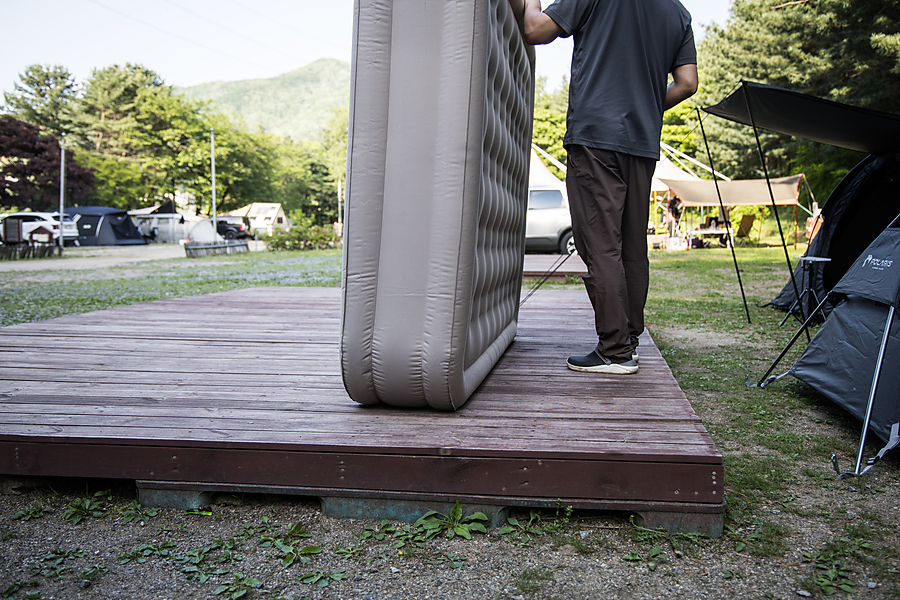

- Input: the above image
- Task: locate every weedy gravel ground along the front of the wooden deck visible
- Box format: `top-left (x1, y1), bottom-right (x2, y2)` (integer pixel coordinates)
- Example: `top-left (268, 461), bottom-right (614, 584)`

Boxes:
top-left (0, 473), bottom-right (898, 600)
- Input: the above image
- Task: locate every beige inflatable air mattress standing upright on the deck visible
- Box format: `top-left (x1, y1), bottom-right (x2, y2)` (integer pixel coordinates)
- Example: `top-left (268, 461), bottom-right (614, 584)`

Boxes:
top-left (341, 0), bottom-right (534, 410)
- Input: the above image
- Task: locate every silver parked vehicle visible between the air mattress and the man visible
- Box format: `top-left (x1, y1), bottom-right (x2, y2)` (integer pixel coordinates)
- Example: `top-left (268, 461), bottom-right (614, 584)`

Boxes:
top-left (525, 185), bottom-right (575, 254)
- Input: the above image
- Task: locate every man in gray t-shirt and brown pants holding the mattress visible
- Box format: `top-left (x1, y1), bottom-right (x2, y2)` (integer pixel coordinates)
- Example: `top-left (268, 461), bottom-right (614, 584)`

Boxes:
top-left (525, 0), bottom-right (697, 374)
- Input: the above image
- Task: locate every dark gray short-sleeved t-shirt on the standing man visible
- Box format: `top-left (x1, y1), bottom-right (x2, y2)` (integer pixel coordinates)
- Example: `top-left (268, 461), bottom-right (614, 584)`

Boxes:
top-left (544, 0), bottom-right (697, 159)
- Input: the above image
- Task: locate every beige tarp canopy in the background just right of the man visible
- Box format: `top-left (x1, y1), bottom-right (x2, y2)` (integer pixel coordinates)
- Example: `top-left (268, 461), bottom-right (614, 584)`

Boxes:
top-left (662, 175), bottom-right (803, 206)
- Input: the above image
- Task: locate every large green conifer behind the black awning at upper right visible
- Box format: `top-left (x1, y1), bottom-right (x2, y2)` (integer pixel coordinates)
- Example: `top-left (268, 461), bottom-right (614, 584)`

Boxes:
top-left (696, 0), bottom-right (900, 198)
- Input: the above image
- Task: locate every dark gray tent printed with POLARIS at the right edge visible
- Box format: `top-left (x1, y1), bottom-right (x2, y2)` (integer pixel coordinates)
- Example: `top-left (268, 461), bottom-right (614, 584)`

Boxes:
top-left (788, 218), bottom-right (900, 474)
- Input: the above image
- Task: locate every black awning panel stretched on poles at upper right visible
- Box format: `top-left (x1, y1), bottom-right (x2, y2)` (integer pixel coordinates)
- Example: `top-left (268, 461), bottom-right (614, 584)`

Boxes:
top-left (704, 81), bottom-right (900, 154)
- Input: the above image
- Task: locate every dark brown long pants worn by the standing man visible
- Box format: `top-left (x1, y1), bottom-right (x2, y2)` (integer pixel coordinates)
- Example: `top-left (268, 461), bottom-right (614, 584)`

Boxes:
top-left (566, 145), bottom-right (656, 359)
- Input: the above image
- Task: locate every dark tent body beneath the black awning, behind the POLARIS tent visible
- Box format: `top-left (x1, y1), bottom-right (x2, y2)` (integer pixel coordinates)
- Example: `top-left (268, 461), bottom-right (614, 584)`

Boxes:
top-left (771, 154), bottom-right (900, 315)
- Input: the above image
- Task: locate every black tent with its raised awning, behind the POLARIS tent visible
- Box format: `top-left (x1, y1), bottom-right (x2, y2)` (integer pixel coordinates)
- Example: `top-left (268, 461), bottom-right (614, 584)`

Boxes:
top-left (705, 82), bottom-right (900, 322)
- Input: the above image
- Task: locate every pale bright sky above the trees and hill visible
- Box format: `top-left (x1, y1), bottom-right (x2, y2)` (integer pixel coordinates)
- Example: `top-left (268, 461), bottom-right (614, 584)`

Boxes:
top-left (0, 0), bottom-right (731, 97)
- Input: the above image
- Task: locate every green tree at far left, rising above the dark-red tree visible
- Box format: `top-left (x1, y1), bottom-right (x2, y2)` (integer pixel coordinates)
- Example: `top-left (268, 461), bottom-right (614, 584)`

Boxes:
top-left (3, 64), bottom-right (78, 139)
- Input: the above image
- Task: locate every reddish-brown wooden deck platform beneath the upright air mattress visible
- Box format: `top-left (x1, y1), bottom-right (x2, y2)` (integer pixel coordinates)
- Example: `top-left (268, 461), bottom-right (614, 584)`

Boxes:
top-left (0, 287), bottom-right (724, 534)
